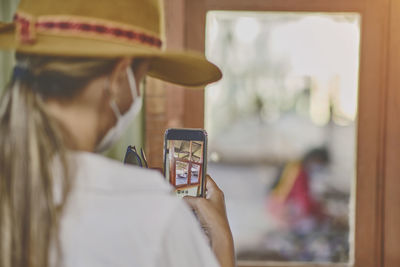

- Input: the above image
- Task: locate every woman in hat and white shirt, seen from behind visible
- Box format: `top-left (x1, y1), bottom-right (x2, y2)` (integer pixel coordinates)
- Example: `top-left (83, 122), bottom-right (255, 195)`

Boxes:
top-left (0, 0), bottom-right (235, 267)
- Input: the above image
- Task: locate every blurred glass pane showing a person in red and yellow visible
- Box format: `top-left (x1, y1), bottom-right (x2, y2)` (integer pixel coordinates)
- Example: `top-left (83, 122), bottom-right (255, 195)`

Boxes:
top-left (205, 11), bottom-right (360, 262)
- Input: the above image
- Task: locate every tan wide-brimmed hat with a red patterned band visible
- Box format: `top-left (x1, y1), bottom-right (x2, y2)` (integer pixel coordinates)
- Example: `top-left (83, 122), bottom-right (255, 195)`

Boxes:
top-left (0, 0), bottom-right (222, 86)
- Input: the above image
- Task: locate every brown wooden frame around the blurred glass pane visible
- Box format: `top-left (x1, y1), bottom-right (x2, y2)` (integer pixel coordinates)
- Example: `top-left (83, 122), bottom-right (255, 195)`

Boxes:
top-left (147, 0), bottom-right (400, 267)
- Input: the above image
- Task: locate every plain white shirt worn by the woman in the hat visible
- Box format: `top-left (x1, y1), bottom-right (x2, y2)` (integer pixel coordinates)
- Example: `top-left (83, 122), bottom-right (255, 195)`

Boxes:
top-left (60, 153), bottom-right (219, 267)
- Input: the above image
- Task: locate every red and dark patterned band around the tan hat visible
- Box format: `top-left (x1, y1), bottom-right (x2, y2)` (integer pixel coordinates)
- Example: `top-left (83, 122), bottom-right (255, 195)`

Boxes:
top-left (14, 12), bottom-right (162, 49)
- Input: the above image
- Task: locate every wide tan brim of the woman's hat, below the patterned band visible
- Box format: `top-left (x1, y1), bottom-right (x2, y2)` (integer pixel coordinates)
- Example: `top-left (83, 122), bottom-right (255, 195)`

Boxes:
top-left (0, 23), bottom-right (222, 87)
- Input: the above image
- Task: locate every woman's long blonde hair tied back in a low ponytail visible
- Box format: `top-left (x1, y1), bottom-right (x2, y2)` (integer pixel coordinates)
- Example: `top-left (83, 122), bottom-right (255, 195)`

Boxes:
top-left (0, 54), bottom-right (116, 267)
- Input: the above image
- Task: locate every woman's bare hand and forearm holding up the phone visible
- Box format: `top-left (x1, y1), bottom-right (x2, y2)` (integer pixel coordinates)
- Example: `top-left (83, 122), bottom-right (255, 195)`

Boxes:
top-left (184, 175), bottom-right (235, 267)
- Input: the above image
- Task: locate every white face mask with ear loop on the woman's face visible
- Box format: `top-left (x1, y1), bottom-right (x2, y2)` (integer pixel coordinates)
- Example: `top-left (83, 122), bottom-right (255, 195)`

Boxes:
top-left (95, 67), bottom-right (143, 152)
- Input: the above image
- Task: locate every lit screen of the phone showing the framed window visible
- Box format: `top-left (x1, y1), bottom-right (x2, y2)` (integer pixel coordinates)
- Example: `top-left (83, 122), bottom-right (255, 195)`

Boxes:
top-left (165, 140), bottom-right (203, 197)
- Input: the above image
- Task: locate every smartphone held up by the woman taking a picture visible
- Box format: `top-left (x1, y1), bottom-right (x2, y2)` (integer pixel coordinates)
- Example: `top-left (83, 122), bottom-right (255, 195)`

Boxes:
top-left (164, 129), bottom-right (207, 197)
